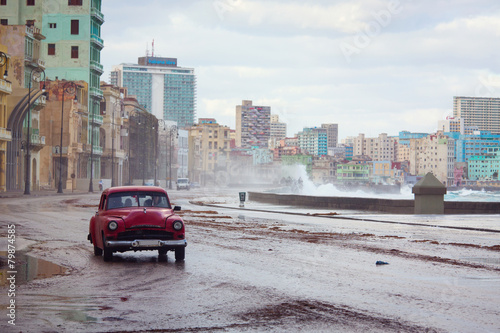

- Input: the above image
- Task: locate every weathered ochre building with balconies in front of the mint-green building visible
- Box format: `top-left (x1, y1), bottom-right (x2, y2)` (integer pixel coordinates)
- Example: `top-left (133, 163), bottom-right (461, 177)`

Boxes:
top-left (0, 25), bottom-right (48, 194)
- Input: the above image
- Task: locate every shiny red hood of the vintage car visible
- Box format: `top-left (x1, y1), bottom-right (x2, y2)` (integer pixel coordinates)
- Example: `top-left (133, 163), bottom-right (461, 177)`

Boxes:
top-left (110, 207), bottom-right (172, 229)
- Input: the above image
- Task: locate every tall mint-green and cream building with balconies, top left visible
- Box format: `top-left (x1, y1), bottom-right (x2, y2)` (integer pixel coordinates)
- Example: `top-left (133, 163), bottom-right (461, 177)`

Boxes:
top-left (0, 0), bottom-right (104, 184)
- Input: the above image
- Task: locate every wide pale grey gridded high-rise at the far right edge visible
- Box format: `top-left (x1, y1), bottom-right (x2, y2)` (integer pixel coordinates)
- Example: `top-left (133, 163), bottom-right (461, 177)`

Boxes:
top-left (453, 96), bottom-right (500, 134)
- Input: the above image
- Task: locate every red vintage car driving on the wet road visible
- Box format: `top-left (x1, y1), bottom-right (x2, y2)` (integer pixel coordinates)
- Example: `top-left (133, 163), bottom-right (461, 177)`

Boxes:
top-left (87, 186), bottom-right (187, 261)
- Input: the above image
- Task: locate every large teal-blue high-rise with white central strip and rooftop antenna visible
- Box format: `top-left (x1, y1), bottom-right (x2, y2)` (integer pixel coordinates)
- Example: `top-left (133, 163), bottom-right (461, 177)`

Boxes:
top-left (111, 56), bottom-right (196, 128)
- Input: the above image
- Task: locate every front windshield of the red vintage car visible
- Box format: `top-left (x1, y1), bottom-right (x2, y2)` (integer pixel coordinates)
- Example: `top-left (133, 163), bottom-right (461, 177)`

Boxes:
top-left (107, 192), bottom-right (170, 209)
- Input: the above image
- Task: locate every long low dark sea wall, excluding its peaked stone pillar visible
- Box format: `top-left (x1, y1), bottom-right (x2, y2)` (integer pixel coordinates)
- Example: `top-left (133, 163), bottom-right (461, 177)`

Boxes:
top-left (248, 192), bottom-right (500, 214)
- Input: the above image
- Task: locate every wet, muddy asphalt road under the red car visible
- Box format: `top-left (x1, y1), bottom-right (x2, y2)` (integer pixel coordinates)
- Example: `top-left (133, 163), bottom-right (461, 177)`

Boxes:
top-left (0, 190), bottom-right (500, 332)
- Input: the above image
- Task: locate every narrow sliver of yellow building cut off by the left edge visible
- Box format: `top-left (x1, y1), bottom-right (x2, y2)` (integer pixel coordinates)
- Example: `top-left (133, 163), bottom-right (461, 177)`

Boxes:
top-left (0, 44), bottom-right (12, 192)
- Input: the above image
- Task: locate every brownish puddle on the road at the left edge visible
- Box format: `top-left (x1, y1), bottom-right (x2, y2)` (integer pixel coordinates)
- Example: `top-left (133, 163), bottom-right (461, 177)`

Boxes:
top-left (0, 251), bottom-right (67, 287)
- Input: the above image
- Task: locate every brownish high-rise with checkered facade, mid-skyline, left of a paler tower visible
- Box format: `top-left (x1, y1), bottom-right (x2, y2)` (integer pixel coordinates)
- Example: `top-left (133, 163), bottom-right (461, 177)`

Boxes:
top-left (236, 101), bottom-right (271, 148)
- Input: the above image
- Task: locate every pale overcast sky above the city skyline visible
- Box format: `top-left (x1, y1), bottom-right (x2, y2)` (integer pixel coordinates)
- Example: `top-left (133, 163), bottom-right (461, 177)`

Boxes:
top-left (101, 0), bottom-right (500, 139)
